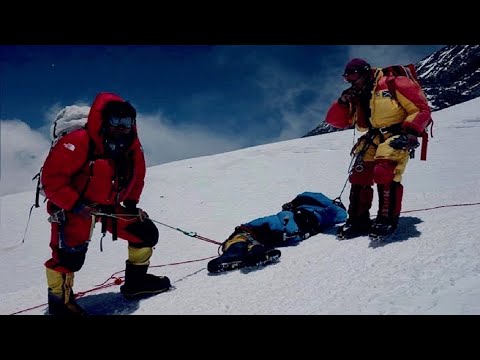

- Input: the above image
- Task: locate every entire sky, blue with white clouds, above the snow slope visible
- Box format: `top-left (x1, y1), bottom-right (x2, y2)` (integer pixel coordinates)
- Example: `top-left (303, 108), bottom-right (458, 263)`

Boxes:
top-left (0, 45), bottom-right (443, 195)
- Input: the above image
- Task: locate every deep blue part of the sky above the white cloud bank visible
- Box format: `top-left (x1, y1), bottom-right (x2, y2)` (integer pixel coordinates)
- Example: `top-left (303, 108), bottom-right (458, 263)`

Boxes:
top-left (1, 45), bottom-right (441, 137)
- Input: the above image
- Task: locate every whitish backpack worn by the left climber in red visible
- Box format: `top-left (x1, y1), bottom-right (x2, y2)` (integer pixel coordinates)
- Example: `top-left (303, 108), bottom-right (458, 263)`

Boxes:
top-left (30, 105), bottom-right (93, 211)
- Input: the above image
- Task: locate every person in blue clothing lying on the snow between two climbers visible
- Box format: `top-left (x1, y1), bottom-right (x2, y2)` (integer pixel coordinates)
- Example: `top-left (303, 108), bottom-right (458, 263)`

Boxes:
top-left (207, 192), bottom-right (347, 273)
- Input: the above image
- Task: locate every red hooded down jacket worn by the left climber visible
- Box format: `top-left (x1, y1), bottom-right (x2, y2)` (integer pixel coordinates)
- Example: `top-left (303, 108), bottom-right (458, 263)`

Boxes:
top-left (41, 93), bottom-right (146, 210)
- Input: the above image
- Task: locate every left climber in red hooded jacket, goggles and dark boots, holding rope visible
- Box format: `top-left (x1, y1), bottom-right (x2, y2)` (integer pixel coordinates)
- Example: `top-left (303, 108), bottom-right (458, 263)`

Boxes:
top-left (41, 93), bottom-right (170, 315)
